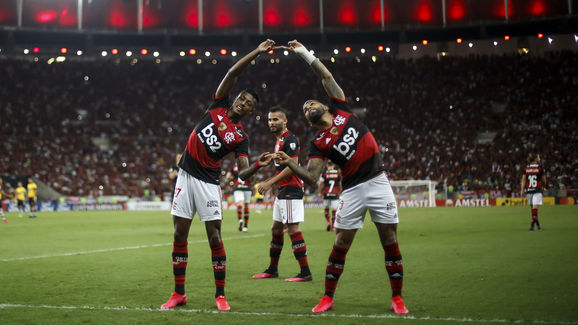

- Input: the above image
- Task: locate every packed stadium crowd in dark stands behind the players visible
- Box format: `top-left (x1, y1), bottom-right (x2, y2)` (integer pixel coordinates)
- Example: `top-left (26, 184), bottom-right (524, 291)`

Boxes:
top-left (0, 52), bottom-right (578, 196)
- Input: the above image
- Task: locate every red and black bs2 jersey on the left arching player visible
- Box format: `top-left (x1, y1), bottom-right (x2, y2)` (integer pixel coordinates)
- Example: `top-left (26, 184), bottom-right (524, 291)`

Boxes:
top-left (179, 95), bottom-right (249, 185)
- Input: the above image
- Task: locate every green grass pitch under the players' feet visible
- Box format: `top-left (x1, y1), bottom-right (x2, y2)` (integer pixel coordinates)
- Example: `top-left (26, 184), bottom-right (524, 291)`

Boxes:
top-left (0, 206), bottom-right (578, 324)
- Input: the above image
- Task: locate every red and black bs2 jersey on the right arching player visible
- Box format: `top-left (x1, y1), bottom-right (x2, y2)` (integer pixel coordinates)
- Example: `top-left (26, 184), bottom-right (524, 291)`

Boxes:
top-left (309, 98), bottom-right (385, 189)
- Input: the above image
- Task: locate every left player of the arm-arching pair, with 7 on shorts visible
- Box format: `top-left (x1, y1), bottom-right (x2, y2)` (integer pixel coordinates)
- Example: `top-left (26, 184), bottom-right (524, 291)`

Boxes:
top-left (161, 39), bottom-right (275, 310)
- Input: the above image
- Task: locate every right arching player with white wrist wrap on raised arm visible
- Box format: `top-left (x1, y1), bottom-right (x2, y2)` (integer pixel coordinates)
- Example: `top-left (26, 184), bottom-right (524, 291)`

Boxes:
top-left (274, 40), bottom-right (408, 314)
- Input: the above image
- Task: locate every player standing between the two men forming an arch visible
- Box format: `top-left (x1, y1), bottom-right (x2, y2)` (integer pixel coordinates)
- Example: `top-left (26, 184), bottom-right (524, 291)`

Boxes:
top-left (253, 108), bottom-right (313, 282)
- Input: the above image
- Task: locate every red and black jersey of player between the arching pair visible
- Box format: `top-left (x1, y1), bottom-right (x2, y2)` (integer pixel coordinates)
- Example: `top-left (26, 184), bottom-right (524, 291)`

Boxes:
top-left (275, 130), bottom-right (303, 200)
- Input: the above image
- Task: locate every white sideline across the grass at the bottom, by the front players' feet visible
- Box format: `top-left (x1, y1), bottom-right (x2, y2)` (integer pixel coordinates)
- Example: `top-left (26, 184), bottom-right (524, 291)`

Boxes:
top-left (0, 303), bottom-right (578, 325)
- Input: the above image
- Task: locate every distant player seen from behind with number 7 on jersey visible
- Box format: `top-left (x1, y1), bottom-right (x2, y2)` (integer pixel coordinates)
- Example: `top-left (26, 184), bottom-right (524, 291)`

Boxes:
top-left (319, 160), bottom-right (342, 231)
